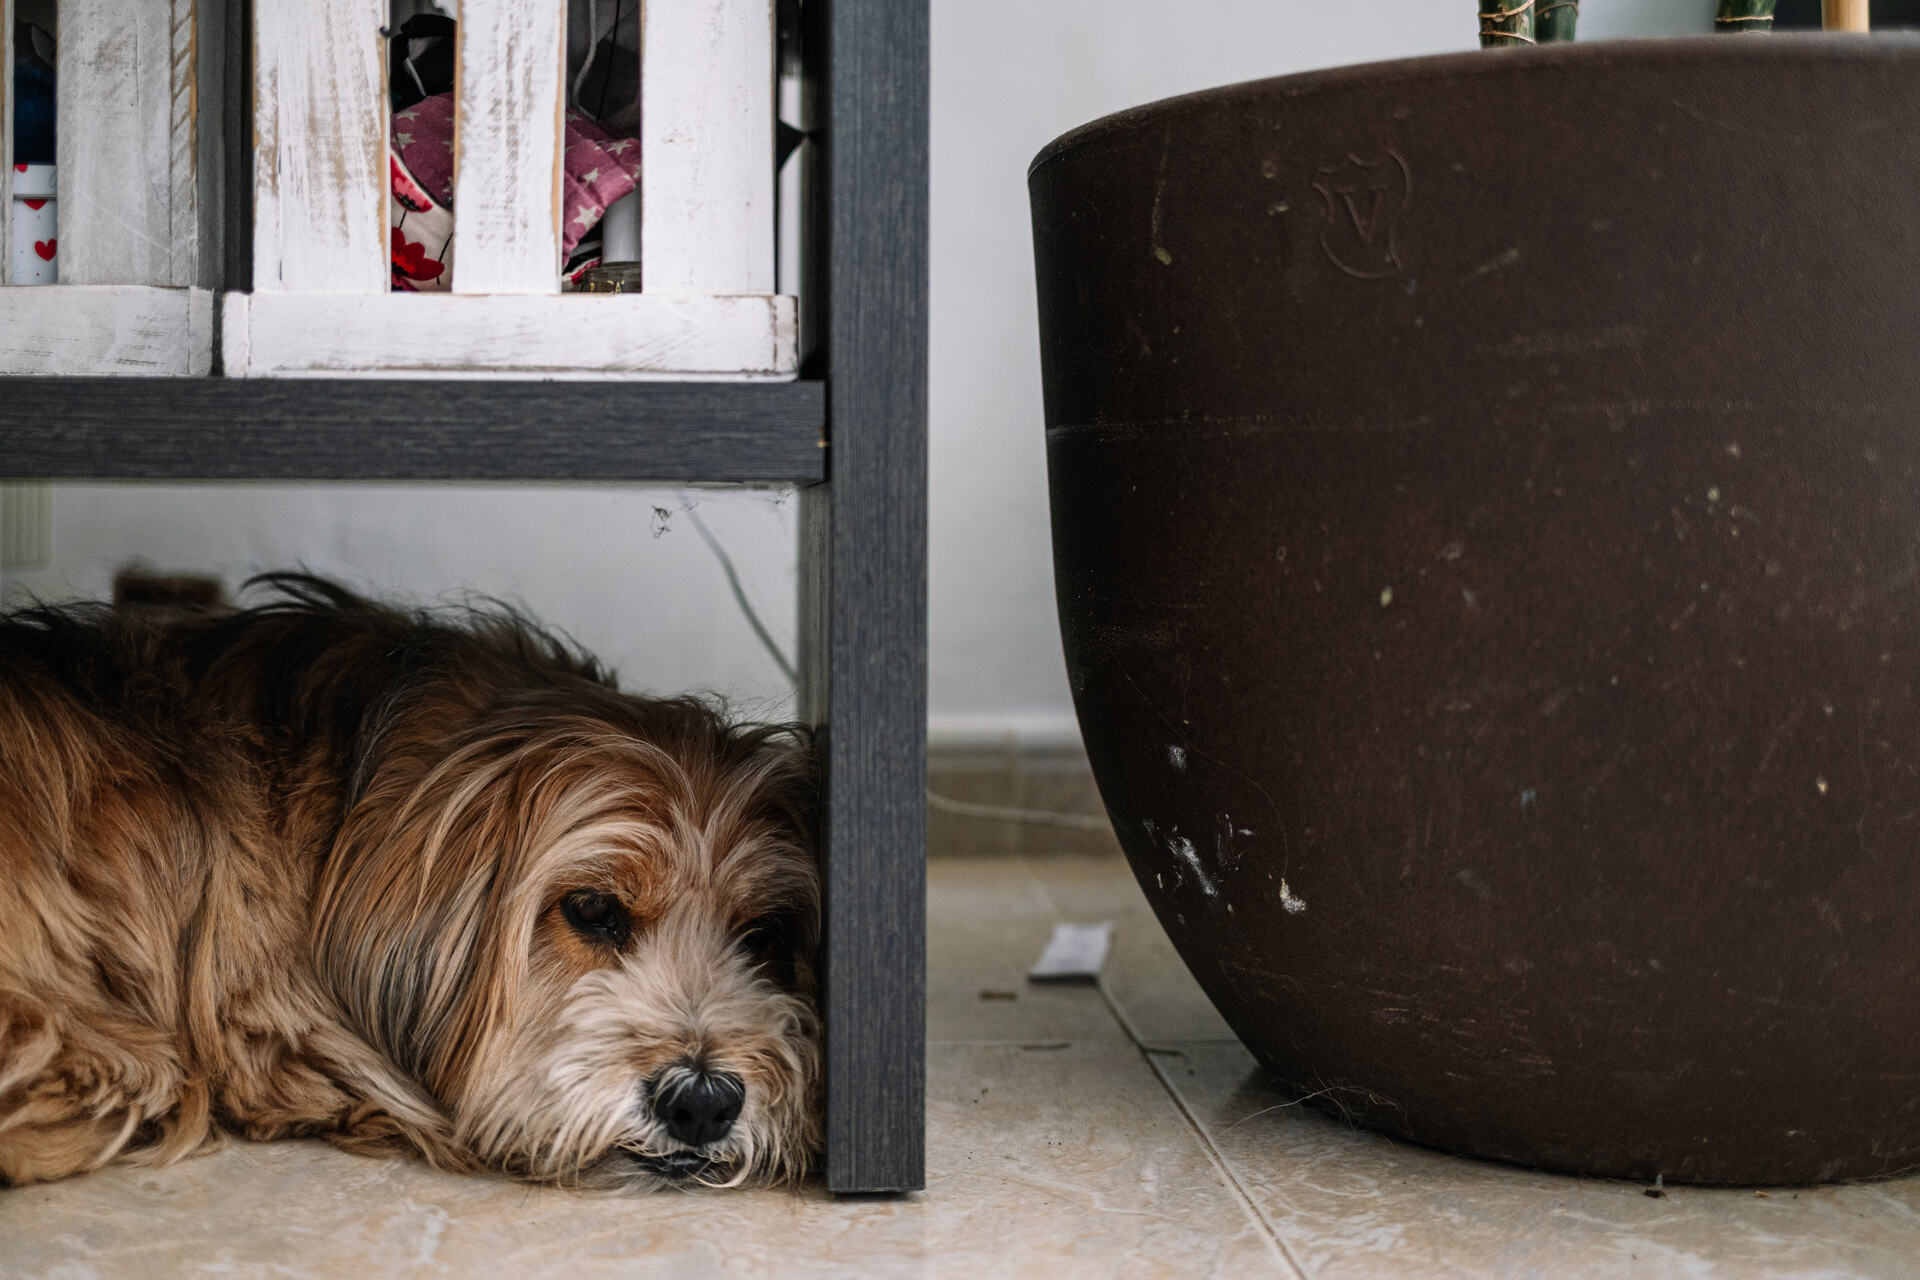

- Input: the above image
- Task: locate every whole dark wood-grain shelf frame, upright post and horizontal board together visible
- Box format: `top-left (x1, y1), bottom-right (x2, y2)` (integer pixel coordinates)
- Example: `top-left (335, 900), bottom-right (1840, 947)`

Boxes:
top-left (0, 0), bottom-right (929, 1194)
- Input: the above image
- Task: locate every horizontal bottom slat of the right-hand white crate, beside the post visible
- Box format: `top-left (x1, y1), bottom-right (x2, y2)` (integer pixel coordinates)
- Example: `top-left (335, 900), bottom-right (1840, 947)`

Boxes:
top-left (221, 293), bottom-right (799, 380)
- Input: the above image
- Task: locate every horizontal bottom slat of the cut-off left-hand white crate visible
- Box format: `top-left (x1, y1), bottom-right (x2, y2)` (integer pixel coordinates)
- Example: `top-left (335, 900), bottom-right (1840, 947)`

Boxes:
top-left (0, 284), bottom-right (213, 378)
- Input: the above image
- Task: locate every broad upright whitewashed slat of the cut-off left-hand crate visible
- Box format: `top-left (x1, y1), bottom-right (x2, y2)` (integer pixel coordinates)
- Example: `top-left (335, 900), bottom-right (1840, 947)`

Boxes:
top-left (56, 0), bottom-right (200, 286)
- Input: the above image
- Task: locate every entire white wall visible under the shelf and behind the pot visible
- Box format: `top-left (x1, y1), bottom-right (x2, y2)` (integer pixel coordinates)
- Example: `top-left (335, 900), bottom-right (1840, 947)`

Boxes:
top-left (0, 0), bottom-right (1713, 743)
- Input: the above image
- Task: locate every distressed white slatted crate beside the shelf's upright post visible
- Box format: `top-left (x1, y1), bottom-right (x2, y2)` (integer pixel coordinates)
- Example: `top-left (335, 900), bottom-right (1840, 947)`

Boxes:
top-left (221, 0), bottom-right (799, 380)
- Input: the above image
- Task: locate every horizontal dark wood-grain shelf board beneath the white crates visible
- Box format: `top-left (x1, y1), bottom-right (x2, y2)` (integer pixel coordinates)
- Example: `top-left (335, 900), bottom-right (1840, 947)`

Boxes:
top-left (0, 378), bottom-right (826, 486)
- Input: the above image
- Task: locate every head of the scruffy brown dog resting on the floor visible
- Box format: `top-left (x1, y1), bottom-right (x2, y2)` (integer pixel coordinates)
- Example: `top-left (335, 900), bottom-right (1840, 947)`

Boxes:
top-left (313, 676), bottom-right (820, 1184)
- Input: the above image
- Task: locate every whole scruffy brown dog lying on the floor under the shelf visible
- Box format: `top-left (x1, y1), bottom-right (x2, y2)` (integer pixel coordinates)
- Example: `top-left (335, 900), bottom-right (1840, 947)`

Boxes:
top-left (0, 576), bottom-right (820, 1186)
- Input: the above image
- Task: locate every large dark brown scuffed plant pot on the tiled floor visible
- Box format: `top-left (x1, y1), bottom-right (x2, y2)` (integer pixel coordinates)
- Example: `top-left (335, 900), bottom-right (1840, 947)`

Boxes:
top-left (1031, 36), bottom-right (1920, 1182)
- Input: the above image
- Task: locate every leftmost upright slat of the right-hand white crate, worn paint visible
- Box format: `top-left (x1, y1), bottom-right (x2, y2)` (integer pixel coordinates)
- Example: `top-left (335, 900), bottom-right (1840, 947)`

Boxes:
top-left (253, 0), bottom-right (392, 294)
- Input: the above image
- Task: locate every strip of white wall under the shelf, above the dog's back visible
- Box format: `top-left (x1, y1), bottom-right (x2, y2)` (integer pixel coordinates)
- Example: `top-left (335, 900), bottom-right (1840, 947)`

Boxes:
top-left (4, 484), bottom-right (797, 720)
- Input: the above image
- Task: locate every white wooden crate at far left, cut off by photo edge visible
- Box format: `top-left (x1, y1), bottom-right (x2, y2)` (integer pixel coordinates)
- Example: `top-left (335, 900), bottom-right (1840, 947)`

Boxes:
top-left (0, 0), bottom-right (221, 374)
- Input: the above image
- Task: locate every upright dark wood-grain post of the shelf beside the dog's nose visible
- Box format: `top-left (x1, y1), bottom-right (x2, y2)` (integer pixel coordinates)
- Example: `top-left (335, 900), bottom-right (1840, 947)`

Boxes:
top-left (801, 0), bottom-right (927, 1192)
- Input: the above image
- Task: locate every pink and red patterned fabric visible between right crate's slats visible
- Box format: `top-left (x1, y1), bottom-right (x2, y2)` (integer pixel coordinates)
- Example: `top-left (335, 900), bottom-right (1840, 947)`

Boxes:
top-left (392, 94), bottom-right (639, 292)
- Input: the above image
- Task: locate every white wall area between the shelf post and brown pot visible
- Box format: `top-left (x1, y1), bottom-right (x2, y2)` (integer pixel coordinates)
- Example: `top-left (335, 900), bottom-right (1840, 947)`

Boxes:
top-left (931, 0), bottom-right (1715, 743)
